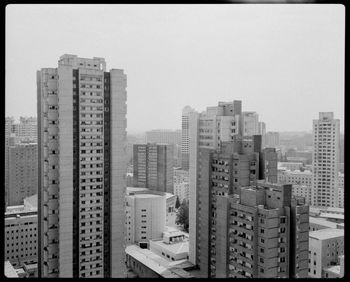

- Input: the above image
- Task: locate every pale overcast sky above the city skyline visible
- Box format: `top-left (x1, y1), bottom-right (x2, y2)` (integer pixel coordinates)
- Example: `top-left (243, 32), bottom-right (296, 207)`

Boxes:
top-left (5, 4), bottom-right (345, 133)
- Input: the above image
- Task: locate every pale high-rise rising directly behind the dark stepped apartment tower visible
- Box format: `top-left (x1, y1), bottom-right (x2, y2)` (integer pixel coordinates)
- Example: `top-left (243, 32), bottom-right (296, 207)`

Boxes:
top-left (189, 101), bottom-right (277, 264)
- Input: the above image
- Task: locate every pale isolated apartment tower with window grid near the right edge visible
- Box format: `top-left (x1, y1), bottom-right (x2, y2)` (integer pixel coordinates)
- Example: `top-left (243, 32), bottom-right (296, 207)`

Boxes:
top-left (311, 112), bottom-right (340, 207)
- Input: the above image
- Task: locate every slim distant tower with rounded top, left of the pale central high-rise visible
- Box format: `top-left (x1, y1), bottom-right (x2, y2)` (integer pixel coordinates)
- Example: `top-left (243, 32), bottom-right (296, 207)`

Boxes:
top-left (181, 106), bottom-right (194, 170)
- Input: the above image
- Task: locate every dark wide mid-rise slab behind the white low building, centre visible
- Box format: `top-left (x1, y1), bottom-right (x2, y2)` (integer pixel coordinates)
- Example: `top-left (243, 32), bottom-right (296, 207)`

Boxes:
top-left (133, 143), bottom-right (174, 193)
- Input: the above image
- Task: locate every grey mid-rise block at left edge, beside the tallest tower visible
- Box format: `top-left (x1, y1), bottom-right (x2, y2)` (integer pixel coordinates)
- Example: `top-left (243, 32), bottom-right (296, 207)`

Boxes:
top-left (6, 143), bottom-right (38, 206)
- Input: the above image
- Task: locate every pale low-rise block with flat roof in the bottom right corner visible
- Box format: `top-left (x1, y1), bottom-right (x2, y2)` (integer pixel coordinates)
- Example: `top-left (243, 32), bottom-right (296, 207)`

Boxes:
top-left (309, 228), bottom-right (344, 278)
